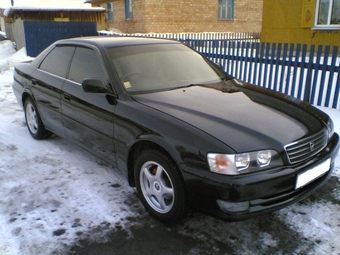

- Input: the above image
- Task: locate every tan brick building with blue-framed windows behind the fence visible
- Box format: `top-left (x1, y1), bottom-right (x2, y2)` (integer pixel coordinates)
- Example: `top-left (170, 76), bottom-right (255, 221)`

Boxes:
top-left (85, 0), bottom-right (263, 33)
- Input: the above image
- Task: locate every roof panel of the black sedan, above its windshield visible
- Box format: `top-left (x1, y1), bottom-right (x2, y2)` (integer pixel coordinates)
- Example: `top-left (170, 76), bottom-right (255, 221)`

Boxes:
top-left (56, 36), bottom-right (180, 48)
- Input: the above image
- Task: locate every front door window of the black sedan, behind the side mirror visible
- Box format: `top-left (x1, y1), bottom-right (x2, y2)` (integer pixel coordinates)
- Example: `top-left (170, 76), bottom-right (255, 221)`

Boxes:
top-left (68, 47), bottom-right (107, 83)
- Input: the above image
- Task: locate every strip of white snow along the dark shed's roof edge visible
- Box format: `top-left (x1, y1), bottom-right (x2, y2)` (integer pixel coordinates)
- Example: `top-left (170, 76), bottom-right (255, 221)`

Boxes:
top-left (4, 6), bottom-right (105, 17)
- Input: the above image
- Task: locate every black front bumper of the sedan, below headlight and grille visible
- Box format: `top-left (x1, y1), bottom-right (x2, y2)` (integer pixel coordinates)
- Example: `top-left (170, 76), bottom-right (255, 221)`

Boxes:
top-left (181, 133), bottom-right (340, 220)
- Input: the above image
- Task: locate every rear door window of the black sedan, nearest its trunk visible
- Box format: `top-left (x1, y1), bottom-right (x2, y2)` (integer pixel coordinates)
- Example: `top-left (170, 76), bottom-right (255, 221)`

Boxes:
top-left (40, 46), bottom-right (75, 78)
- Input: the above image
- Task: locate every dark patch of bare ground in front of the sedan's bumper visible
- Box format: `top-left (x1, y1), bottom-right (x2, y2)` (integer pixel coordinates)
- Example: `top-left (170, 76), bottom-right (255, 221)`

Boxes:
top-left (69, 193), bottom-right (322, 255)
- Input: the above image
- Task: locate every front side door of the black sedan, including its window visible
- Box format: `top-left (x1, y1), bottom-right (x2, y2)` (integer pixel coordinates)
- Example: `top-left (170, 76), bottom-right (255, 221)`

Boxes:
top-left (61, 47), bottom-right (116, 165)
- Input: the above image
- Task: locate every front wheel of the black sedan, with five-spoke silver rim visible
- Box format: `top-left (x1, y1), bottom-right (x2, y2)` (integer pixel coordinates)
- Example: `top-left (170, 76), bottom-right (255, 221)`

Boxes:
top-left (134, 150), bottom-right (187, 223)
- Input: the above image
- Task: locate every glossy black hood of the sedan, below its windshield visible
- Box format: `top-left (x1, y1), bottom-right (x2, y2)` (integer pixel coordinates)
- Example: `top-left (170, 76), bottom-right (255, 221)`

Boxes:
top-left (133, 81), bottom-right (321, 152)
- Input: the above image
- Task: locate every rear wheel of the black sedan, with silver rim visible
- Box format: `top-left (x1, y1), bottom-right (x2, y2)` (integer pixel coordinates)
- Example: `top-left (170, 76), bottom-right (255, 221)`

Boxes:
top-left (24, 97), bottom-right (52, 140)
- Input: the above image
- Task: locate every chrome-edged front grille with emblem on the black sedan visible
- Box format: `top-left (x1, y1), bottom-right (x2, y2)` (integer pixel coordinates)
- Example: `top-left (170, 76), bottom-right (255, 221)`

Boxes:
top-left (285, 130), bottom-right (327, 164)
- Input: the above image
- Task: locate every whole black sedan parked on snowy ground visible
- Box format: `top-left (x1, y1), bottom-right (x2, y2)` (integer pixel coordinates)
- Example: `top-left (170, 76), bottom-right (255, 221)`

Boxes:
top-left (13, 37), bottom-right (339, 222)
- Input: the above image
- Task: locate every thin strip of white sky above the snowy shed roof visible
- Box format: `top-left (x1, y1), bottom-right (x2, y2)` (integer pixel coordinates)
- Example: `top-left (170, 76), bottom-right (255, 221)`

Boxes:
top-left (0, 0), bottom-right (89, 8)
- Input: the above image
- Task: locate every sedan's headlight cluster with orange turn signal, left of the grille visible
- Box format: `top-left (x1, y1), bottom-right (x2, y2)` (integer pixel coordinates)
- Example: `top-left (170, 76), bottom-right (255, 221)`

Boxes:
top-left (208, 150), bottom-right (283, 175)
